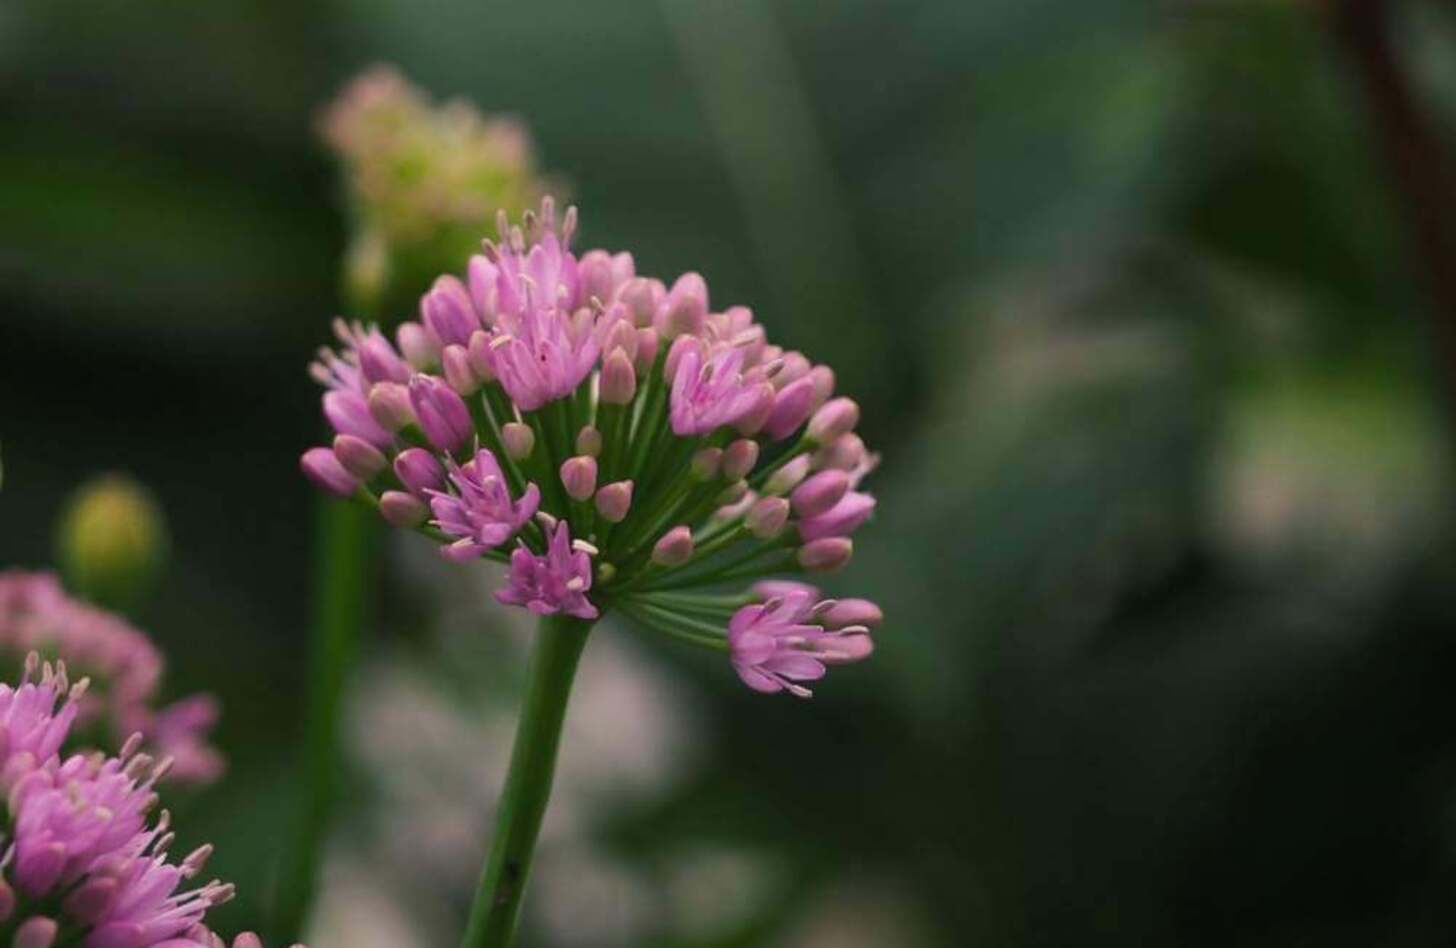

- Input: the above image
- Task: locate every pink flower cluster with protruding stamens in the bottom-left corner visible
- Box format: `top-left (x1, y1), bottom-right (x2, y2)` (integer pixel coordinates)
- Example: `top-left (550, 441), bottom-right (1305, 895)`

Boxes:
top-left (0, 652), bottom-right (295, 948)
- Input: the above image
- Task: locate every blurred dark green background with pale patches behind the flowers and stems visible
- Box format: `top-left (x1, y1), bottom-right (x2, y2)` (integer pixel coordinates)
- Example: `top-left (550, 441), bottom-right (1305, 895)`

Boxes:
top-left (0, 0), bottom-right (1456, 948)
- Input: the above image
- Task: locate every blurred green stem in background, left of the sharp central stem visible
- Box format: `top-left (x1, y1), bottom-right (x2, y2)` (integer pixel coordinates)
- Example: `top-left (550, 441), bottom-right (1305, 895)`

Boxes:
top-left (274, 498), bottom-right (376, 944)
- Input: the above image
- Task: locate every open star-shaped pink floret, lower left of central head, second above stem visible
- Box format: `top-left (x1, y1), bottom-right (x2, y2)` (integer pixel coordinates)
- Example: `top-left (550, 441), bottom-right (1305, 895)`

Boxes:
top-left (425, 449), bottom-right (540, 562)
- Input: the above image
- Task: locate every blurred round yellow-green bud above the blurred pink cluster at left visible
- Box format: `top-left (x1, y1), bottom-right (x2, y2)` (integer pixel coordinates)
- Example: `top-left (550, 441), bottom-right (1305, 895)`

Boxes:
top-left (57, 474), bottom-right (168, 609)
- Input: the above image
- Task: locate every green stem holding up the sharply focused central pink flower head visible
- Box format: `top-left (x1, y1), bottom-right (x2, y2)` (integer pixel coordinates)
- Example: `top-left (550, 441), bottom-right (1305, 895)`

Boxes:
top-left (460, 616), bottom-right (591, 948)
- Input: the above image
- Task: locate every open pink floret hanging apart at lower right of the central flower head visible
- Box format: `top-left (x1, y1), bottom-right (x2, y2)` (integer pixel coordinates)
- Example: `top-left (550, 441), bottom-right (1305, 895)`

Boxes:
top-left (728, 590), bottom-right (874, 698)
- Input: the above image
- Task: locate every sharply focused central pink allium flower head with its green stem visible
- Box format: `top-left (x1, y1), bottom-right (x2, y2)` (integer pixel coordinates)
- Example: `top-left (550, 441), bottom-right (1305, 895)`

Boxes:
top-left (301, 198), bottom-right (881, 948)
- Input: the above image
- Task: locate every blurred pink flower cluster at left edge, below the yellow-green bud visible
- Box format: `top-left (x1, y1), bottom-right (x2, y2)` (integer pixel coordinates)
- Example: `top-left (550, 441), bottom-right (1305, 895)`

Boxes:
top-left (0, 569), bottom-right (224, 783)
